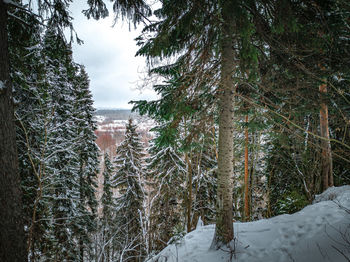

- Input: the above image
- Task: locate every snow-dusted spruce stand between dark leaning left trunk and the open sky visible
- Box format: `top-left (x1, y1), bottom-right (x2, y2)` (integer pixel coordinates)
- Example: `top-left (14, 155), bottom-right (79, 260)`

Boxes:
top-left (10, 15), bottom-right (98, 261)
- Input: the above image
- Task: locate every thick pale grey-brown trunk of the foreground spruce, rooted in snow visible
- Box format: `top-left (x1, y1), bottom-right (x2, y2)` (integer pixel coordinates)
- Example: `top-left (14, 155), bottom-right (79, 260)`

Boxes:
top-left (211, 0), bottom-right (235, 249)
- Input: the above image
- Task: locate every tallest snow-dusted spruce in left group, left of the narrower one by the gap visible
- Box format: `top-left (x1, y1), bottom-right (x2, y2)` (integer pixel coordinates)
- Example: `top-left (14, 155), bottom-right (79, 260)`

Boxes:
top-left (44, 29), bottom-right (82, 260)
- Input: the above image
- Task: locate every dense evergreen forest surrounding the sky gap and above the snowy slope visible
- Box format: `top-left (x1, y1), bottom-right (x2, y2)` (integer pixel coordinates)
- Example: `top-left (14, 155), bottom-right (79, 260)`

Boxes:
top-left (0, 0), bottom-right (350, 261)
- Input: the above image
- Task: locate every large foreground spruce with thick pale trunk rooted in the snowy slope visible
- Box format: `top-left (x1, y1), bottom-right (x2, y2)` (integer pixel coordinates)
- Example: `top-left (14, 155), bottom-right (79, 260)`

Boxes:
top-left (134, 1), bottom-right (257, 248)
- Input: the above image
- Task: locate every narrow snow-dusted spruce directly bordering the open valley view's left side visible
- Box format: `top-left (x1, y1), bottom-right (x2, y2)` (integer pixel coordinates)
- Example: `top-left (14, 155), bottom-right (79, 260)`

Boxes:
top-left (73, 66), bottom-right (99, 261)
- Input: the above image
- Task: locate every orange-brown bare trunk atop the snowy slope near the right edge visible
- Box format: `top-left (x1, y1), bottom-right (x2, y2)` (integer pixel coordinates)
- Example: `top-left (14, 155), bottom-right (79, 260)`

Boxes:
top-left (320, 83), bottom-right (333, 190)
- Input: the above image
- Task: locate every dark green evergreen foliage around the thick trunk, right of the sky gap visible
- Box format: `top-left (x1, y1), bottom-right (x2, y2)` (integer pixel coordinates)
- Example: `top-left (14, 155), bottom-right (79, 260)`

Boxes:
top-left (134, 1), bottom-right (349, 248)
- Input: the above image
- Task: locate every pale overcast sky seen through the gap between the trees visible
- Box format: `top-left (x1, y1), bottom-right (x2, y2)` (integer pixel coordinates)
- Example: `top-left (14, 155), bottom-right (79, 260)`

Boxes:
top-left (71, 0), bottom-right (156, 108)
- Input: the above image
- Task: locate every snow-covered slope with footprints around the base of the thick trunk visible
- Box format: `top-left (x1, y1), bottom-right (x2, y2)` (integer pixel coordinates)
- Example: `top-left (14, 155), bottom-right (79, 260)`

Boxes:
top-left (149, 186), bottom-right (350, 262)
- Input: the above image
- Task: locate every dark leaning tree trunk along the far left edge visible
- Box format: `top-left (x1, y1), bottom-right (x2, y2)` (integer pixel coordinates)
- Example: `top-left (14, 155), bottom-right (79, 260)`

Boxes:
top-left (0, 1), bottom-right (27, 262)
